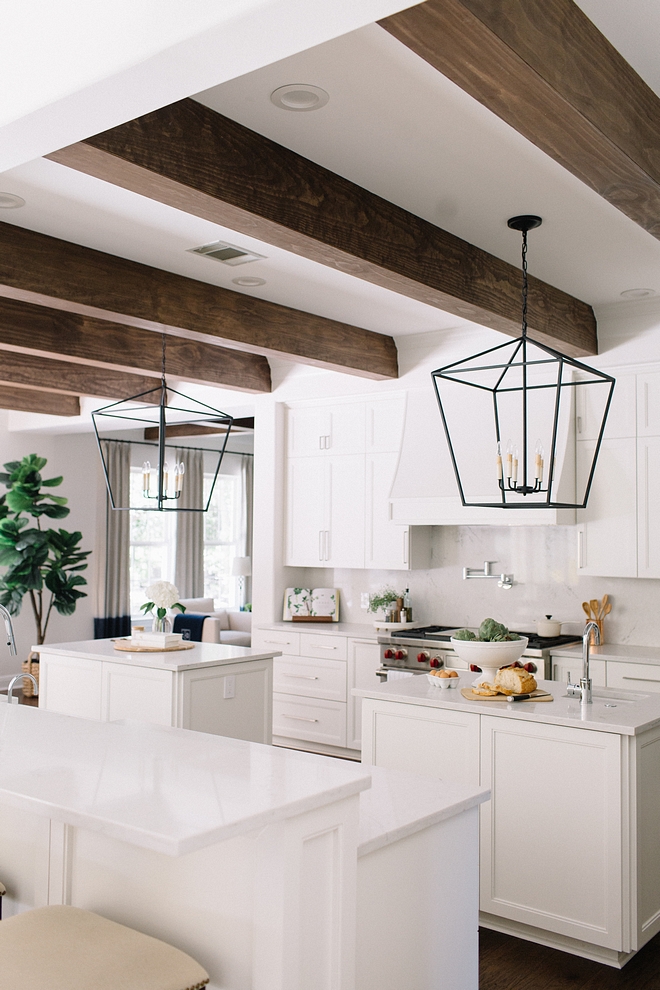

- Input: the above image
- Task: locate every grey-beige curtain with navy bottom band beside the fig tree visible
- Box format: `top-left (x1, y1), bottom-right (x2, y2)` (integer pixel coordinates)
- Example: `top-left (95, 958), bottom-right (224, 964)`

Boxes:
top-left (94, 440), bottom-right (131, 639)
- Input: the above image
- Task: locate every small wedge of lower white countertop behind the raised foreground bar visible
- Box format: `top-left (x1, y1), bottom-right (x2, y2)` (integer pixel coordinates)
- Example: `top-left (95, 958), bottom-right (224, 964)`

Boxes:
top-left (358, 766), bottom-right (490, 856)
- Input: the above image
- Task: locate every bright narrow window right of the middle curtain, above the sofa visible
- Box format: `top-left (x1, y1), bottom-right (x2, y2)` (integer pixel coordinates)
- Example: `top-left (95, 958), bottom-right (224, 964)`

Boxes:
top-left (204, 474), bottom-right (243, 608)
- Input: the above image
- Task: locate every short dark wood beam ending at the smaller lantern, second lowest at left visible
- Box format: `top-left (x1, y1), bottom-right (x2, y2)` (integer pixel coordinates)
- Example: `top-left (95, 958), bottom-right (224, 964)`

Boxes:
top-left (0, 351), bottom-right (160, 405)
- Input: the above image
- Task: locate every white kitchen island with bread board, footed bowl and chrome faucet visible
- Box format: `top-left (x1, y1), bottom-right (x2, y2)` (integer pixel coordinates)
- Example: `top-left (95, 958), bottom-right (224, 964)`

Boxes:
top-left (355, 675), bottom-right (660, 967)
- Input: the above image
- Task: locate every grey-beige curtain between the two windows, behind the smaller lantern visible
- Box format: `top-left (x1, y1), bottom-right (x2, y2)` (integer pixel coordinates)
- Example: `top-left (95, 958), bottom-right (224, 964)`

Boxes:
top-left (174, 447), bottom-right (204, 598)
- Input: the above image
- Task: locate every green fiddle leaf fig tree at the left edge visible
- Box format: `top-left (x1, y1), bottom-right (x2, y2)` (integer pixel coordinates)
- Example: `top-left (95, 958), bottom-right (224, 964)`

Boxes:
top-left (0, 454), bottom-right (91, 645)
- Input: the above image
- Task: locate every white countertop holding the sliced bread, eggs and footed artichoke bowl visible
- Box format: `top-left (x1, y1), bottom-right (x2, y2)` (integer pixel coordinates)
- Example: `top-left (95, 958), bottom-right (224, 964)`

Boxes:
top-left (353, 673), bottom-right (660, 736)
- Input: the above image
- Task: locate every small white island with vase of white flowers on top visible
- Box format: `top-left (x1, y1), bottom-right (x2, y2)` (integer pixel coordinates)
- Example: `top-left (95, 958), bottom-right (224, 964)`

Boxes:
top-left (36, 639), bottom-right (279, 743)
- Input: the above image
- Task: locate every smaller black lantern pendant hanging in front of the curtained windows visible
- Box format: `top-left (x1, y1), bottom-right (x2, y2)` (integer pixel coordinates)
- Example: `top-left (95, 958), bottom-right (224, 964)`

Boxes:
top-left (92, 334), bottom-right (234, 512)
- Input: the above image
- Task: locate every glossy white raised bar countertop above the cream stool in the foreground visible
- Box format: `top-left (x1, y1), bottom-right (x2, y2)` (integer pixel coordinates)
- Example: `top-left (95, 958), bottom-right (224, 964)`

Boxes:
top-left (0, 704), bottom-right (371, 856)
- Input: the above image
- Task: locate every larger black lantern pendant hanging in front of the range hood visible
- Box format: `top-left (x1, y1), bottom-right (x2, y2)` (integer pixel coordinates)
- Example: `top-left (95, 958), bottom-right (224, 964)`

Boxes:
top-left (432, 216), bottom-right (614, 509)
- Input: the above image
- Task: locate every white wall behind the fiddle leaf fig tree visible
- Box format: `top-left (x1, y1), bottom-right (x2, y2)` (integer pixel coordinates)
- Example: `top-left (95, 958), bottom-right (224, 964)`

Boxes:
top-left (0, 412), bottom-right (98, 686)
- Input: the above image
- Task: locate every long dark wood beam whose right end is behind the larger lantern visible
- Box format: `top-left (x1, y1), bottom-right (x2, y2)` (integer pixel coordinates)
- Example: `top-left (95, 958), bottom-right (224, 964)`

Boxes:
top-left (49, 100), bottom-right (597, 356)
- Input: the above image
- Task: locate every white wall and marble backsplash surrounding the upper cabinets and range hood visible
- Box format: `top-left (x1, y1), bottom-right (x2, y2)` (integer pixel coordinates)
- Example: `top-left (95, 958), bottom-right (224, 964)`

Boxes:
top-left (254, 299), bottom-right (660, 646)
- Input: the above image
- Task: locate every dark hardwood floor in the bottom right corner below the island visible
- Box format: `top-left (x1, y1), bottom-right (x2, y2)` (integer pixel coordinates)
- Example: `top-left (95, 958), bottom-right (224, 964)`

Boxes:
top-left (480, 928), bottom-right (660, 990)
